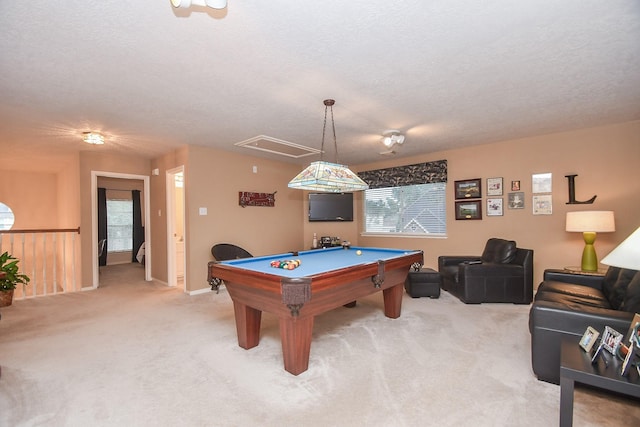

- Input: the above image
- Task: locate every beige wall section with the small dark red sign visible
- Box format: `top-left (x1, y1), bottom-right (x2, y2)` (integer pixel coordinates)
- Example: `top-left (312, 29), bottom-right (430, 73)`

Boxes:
top-left (185, 146), bottom-right (303, 290)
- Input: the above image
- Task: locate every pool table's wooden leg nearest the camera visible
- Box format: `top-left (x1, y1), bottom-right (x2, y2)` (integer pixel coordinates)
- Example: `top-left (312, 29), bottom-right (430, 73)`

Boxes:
top-left (280, 316), bottom-right (314, 375)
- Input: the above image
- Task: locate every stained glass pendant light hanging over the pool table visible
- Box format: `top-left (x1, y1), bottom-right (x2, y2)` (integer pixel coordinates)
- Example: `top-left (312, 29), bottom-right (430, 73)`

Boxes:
top-left (289, 99), bottom-right (369, 193)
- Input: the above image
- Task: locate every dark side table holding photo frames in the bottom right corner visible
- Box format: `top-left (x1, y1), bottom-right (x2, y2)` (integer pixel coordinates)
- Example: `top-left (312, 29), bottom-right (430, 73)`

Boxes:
top-left (560, 339), bottom-right (640, 427)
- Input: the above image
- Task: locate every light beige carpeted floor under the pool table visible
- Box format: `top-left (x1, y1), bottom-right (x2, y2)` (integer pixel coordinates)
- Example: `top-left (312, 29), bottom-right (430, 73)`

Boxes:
top-left (0, 265), bottom-right (640, 427)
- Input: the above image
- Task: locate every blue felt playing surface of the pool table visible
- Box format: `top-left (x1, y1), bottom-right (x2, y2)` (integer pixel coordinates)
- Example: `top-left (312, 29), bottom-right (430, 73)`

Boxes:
top-left (221, 246), bottom-right (419, 278)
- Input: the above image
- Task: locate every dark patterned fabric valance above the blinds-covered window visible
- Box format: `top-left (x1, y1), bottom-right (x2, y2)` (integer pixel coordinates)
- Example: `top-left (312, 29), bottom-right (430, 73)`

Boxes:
top-left (357, 160), bottom-right (447, 188)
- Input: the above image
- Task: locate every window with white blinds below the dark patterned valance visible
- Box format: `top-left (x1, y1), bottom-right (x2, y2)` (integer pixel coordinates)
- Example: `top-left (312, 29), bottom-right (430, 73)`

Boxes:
top-left (364, 182), bottom-right (447, 236)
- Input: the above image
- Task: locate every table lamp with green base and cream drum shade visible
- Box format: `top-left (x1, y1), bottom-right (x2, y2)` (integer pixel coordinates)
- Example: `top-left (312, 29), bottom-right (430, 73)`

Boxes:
top-left (566, 211), bottom-right (616, 271)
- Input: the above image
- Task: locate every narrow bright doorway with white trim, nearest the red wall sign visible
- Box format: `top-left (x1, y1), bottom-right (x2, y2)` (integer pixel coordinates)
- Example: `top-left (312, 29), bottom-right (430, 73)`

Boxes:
top-left (166, 166), bottom-right (187, 291)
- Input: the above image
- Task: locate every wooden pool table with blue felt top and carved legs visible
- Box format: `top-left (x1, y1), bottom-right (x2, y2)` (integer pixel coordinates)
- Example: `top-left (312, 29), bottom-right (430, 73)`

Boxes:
top-left (208, 247), bottom-right (423, 375)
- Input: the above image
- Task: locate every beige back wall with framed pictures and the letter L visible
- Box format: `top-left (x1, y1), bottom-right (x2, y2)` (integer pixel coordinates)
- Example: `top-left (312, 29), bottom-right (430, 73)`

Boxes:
top-left (340, 121), bottom-right (640, 283)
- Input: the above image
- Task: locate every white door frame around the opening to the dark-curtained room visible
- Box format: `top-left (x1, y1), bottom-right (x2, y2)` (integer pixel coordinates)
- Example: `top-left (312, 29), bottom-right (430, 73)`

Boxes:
top-left (91, 171), bottom-right (152, 289)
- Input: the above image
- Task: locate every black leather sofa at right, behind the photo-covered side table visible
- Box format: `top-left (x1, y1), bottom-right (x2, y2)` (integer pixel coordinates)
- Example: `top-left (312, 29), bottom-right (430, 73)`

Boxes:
top-left (529, 267), bottom-right (640, 384)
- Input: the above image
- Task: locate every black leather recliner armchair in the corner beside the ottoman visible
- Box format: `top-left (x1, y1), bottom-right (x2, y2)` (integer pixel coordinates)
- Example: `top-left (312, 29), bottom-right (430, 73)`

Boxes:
top-left (438, 238), bottom-right (533, 304)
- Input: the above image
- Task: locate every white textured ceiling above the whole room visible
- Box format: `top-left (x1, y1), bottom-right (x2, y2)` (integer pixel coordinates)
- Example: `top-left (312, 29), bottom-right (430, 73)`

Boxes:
top-left (0, 0), bottom-right (640, 169)
